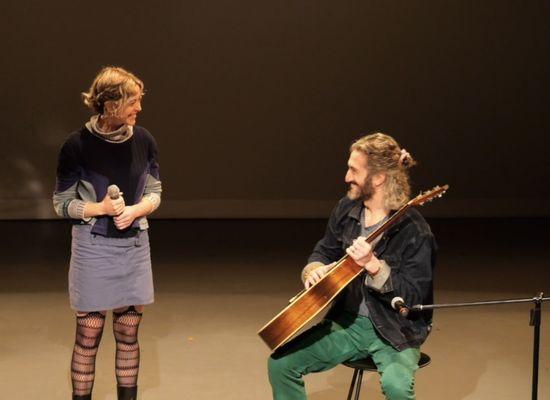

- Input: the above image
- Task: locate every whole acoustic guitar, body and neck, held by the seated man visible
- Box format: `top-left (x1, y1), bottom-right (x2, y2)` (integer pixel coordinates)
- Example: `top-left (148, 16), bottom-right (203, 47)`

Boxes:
top-left (258, 185), bottom-right (449, 350)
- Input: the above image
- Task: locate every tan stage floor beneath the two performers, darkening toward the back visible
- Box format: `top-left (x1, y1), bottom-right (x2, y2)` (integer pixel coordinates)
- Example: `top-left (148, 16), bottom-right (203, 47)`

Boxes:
top-left (0, 219), bottom-right (550, 400)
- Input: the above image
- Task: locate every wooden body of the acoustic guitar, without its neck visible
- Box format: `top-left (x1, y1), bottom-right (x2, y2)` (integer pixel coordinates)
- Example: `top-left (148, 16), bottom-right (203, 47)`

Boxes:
top-left (258, 258), bottom-right (364, 350)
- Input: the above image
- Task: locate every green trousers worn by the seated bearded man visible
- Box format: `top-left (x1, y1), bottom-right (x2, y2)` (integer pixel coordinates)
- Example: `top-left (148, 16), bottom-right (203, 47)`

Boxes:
top-left (268, 313), bottom-right (420, 400)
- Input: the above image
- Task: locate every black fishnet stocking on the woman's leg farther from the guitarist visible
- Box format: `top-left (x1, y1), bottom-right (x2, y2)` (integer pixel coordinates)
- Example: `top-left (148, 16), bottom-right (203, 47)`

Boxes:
top-left (71, 312), bottom-right (105, 396)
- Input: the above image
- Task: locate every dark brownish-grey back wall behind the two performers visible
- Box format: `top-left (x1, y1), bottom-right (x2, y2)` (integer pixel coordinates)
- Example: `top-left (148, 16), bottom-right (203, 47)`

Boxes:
top-left (0, 0), bottom-right (550, 219)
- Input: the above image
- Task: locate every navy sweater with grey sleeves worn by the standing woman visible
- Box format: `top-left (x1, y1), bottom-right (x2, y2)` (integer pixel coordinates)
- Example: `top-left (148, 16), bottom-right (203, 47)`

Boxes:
top-left (54, 126), bottom-right (160, 237)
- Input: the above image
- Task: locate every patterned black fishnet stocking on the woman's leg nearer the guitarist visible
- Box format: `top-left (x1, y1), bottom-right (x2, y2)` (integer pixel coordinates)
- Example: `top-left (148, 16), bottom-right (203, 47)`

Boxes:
top-left (113, 307), bottom-right (142, 387)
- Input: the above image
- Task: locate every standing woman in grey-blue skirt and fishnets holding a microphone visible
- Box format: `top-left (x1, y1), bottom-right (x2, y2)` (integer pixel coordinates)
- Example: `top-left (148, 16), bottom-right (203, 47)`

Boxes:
top-left (53, 67), bottom-right (161, 400)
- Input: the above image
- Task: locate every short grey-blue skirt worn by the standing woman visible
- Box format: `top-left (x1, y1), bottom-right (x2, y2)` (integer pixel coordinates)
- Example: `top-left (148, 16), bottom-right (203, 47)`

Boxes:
top-left (69, 225), bottom-right (154, 312)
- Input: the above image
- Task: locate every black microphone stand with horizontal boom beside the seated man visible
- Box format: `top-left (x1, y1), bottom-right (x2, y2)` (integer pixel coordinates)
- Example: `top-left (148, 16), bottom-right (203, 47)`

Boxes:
top-left (416, 292), bottom-right (550, 400)
